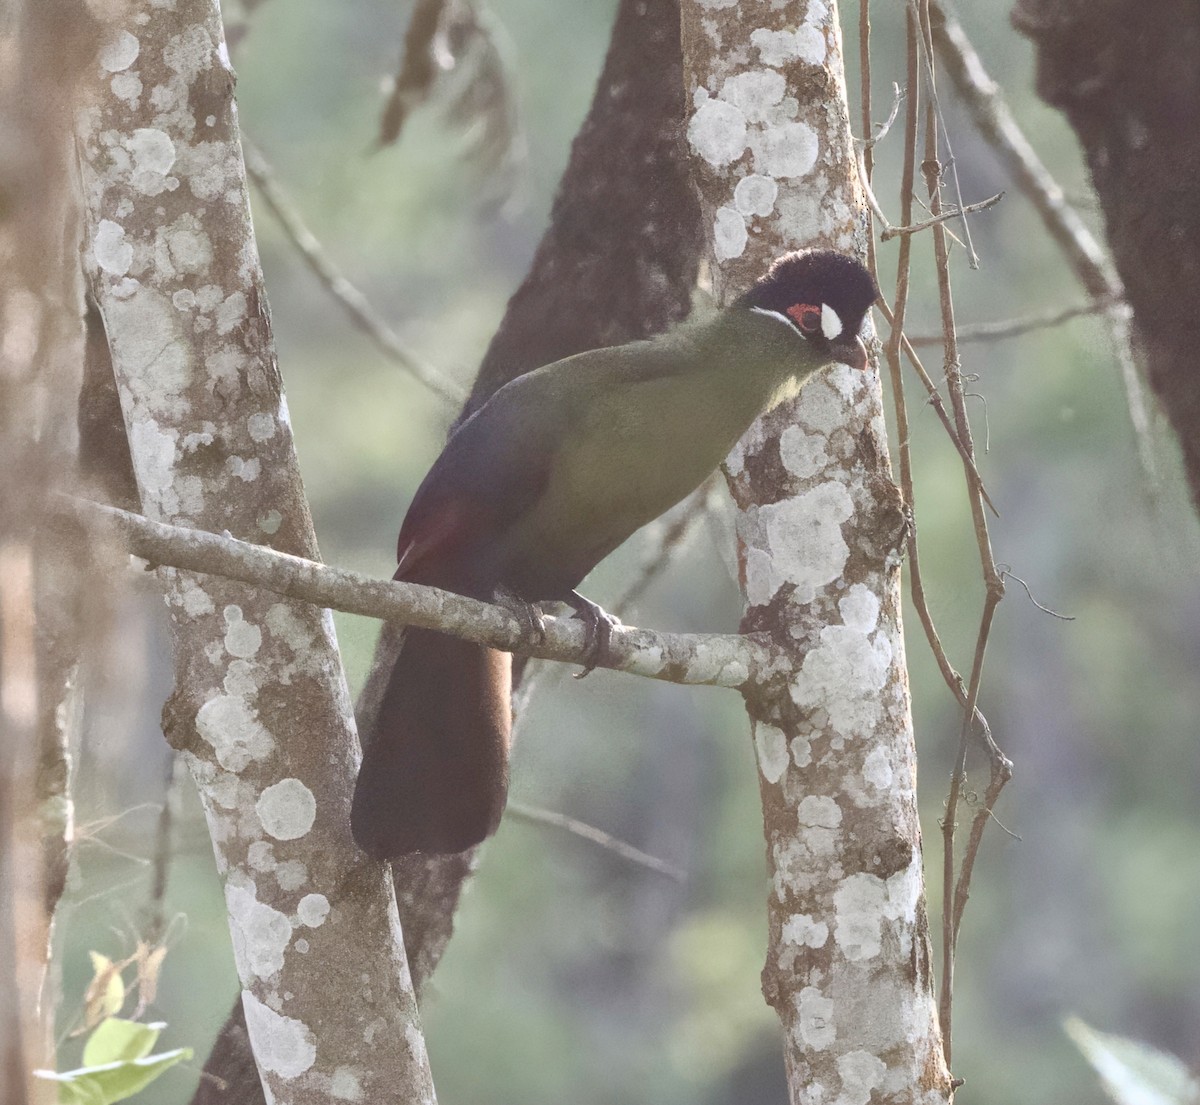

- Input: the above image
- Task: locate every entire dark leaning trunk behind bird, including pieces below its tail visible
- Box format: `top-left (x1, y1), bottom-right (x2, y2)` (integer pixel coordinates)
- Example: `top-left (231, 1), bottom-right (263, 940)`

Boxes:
top-left (193, 0), bottom-right (703, 1089)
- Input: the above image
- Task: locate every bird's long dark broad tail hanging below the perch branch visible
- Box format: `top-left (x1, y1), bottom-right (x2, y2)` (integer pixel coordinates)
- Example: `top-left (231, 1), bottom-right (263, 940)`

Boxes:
top-left (350, 629), bottom-right (512, 859)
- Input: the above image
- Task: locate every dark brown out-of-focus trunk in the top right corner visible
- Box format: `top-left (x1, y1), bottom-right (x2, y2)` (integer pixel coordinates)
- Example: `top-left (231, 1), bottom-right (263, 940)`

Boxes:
top-left (1013, 0), bottom-right (1200, 509)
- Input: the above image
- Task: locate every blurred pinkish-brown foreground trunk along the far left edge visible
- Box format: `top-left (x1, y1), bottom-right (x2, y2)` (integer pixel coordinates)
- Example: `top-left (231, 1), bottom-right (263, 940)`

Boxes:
top-left (0, 0), bottom-right (97, 1105)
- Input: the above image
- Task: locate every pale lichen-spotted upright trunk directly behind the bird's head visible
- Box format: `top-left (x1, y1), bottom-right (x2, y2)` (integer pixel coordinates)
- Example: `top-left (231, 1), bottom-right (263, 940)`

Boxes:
top-left (683, 0), bottom-right (950, 1105)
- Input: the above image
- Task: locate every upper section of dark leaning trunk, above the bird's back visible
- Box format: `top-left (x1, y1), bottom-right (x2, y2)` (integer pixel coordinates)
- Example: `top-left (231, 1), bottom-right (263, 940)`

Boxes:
top-left (462, 0), bottom-right (703, 418)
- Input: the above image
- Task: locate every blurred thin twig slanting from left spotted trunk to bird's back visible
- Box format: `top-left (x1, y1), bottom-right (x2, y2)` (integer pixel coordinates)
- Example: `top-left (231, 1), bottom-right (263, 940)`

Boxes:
top-left (241, 136), bottom-right (467, 406)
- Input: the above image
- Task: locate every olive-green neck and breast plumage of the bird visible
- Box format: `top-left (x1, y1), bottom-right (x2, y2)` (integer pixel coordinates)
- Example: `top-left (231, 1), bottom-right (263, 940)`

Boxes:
top-left (496, 311), bottom-right (817, 587)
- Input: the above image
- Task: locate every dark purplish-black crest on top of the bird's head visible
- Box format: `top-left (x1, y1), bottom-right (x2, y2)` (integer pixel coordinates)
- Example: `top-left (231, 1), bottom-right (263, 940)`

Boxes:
top-left (737, 250), bottom-right (878, 341)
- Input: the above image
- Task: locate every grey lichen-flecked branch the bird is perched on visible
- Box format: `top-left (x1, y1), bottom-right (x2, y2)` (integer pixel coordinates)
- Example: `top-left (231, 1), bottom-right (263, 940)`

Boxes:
top-left (68, 496), bottom-right (775, 689)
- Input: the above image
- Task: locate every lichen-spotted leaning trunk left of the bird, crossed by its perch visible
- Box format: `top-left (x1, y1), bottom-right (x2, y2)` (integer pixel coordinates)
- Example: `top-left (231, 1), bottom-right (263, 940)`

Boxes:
top-left (79, 0), bottom-right (433, 1103)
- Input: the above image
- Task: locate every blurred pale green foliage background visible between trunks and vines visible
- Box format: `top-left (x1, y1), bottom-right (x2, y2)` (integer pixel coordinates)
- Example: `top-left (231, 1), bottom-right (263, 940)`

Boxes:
top-left (59, 0), bottom-right (1200, 1105)
